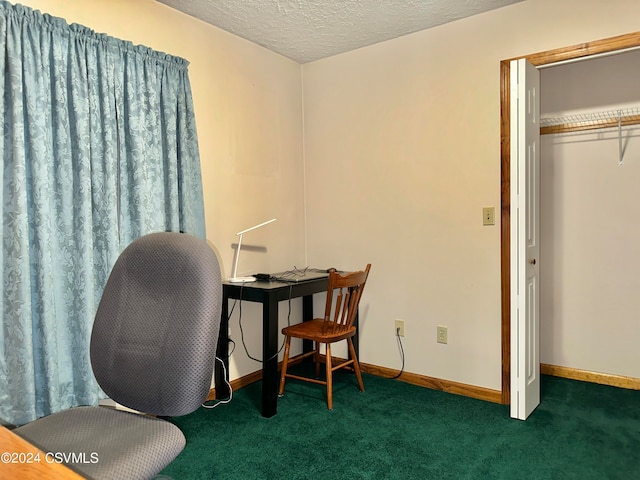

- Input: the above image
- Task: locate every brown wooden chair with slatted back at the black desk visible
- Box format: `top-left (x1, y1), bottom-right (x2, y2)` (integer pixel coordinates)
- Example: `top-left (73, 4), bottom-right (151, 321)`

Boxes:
top-left (279, 264), bottom-right (371, 410)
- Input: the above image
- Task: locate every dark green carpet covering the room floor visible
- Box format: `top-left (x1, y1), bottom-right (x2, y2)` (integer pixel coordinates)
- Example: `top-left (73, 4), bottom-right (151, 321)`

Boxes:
top-left (163, 372), bottom-right (640, 480)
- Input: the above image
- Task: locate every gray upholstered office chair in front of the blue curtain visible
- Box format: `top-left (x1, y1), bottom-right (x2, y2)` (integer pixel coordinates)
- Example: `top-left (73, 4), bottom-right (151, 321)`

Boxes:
top-left (14, 232), bottom-right (222, 480)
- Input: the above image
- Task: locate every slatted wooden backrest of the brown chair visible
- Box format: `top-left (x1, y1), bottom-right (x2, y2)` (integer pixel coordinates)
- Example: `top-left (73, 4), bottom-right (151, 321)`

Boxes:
top-left (324, 264), bottom-right (371, 333)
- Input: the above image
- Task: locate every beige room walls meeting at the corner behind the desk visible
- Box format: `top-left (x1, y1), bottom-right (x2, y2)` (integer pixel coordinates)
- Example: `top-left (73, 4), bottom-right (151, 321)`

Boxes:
top-left (12, 0), bottom-right (640, 389)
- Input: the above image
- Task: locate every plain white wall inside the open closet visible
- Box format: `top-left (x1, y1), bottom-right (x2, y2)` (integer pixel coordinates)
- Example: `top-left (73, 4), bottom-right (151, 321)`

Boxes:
top-left (540, 51), bottom-right (640, 378)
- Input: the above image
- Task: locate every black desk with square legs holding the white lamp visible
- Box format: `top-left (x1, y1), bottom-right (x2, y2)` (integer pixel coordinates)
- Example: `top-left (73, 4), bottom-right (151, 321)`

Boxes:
top-left (215, 278), bottom-right (336, 417)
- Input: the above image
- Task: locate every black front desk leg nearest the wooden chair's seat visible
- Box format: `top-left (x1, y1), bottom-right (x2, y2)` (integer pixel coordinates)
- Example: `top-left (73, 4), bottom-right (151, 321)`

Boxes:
top-left (262, 298), bottom-right (280, 417)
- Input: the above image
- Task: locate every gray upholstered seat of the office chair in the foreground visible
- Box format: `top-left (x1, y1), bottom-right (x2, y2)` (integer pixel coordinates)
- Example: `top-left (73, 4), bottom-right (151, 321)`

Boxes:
top-left (14, 407), bottom-right (186, 480)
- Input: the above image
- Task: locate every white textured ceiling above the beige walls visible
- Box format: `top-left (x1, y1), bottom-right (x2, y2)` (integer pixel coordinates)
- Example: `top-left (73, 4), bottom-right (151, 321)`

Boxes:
top-left (156, 0), bottom-right (522, 63)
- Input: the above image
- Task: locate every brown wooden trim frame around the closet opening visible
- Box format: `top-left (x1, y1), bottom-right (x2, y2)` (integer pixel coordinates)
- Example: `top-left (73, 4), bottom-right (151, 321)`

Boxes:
top-left (500, 32), bottom-right (640, 405)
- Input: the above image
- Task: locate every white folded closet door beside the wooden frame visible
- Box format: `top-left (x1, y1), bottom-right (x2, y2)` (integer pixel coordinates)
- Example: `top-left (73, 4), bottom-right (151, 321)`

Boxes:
top-left (510, 59), bottom-right (540, 420)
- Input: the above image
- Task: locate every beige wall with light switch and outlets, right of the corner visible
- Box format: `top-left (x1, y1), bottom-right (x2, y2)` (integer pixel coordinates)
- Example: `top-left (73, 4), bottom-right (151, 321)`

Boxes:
top-left (303, 0), bottom-right (640, 390)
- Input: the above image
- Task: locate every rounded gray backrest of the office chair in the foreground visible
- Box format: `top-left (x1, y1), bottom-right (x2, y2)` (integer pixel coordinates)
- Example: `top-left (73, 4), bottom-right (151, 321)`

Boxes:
top-left (91, 232), bottom-right (222, 416)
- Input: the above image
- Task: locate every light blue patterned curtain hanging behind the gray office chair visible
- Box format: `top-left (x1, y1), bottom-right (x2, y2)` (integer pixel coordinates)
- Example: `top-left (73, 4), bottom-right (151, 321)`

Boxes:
top-left (0, 1), bottom-right (205, 425)
